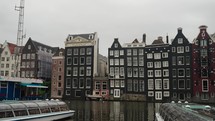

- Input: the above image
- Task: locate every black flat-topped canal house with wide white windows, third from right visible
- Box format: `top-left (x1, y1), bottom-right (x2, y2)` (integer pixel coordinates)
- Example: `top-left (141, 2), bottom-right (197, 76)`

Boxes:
top-left (145, 36), bottom-right (171, 101)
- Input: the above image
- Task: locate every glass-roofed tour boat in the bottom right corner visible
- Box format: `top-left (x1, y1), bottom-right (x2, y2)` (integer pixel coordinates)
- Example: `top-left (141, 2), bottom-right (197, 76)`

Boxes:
top-left (155, 102), bottom-right (215, 121)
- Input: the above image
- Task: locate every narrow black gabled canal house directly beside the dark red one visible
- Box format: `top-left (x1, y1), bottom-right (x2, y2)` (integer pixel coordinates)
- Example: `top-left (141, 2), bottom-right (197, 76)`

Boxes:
top-left (171, 28), bottom-right (192, 101)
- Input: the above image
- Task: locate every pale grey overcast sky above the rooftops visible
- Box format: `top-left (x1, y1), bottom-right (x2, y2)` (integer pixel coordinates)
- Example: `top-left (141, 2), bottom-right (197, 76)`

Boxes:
top-left (0, 0), bottom-right (215, 56)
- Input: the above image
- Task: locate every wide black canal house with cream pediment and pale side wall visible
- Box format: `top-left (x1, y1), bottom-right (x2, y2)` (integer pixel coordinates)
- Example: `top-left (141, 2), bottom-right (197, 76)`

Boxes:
top-left (63, 32), bottom-right (99, 99)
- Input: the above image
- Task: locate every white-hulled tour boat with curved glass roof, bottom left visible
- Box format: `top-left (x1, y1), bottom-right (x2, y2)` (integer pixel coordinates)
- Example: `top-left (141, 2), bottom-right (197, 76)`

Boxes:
top-left (0, 100), bottom-right (75, 121)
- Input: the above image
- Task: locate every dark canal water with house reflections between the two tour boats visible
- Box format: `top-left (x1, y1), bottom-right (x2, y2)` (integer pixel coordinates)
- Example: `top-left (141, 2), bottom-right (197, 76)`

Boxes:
top-left (67, 101), bottom-right (160, 121)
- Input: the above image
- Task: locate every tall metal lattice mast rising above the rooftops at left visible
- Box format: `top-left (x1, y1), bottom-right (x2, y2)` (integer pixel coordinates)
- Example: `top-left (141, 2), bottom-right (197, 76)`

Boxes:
top-left (15, 0), bottom-right (25, 46)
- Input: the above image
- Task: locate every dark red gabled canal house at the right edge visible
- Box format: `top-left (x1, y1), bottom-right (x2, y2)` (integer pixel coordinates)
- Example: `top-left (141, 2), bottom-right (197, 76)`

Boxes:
top-left (192, 25), bottom-right (215, 102)
